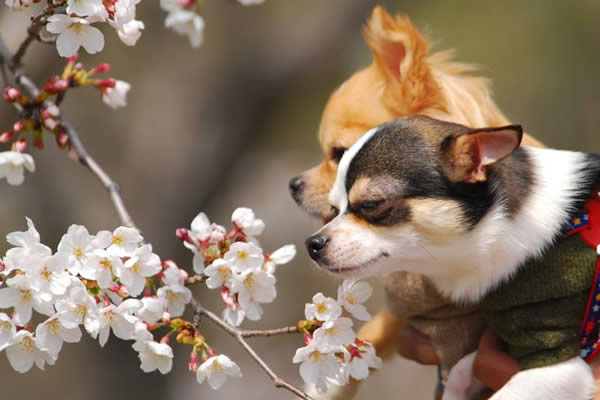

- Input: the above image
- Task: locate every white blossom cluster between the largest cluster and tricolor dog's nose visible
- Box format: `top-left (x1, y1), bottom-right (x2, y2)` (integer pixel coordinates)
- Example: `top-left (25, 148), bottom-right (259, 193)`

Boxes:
top-left (177, 208), bottom-right (296, 326)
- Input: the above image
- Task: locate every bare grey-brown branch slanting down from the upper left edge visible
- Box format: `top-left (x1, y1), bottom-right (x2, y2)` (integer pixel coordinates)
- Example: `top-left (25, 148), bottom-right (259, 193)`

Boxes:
top-left (0, 38), bottom-right (136, 228)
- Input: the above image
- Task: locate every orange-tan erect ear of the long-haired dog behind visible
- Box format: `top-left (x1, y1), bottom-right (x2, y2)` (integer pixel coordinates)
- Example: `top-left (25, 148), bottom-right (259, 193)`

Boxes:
top-left (364, 6), bottom-right (445, 115)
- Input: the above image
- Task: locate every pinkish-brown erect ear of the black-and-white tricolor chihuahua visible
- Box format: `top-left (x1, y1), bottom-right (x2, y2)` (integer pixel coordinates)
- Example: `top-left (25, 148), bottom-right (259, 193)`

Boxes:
top-left (442, 125), bottom-right (523, 183)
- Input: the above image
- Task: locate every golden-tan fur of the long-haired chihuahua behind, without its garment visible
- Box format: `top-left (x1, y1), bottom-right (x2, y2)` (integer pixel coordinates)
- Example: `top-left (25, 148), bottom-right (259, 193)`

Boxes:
top-left (294, 7), bottom-right (542, 396)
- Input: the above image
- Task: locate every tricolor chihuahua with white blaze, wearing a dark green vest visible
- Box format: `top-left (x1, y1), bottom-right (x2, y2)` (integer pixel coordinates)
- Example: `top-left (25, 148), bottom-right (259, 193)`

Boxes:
top-left (306, 116), bottom-right (600, 400)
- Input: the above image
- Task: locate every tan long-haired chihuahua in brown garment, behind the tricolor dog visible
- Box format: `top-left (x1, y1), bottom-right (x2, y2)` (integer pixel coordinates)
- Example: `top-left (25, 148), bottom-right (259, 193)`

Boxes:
top-left (289, 7), bottom-right (541, 399)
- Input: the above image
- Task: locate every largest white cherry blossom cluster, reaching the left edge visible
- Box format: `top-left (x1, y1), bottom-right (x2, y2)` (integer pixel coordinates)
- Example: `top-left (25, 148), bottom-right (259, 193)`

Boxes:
top-left (0, 219), bottom-right (196, 373)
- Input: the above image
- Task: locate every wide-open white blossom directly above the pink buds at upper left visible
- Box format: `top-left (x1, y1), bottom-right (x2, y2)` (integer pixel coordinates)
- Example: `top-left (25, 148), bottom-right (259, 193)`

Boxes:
top-left (46, 15), bottom-right (104, 57)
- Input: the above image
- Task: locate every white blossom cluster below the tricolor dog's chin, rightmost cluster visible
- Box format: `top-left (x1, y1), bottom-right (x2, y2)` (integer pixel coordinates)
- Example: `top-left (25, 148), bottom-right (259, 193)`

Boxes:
top-left (293, 280), bottom-right (381, 393)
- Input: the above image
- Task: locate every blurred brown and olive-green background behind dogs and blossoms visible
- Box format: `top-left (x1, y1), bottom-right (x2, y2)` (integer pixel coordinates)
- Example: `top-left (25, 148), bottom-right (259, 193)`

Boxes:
top-left (0, 0), bottom-right (600, 400)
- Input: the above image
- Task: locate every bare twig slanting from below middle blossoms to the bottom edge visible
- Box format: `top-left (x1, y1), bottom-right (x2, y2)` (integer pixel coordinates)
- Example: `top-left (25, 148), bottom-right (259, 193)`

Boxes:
top-left (191, 298), bottom-right (312, 400)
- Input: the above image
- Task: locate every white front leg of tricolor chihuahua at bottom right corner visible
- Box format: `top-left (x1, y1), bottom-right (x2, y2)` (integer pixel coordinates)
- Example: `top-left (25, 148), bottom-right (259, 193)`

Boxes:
top-left (490, 357), bottom-right (596, 400)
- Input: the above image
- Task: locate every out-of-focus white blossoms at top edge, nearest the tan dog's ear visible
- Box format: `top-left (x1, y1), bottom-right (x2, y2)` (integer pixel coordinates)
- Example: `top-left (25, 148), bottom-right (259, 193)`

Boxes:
top-left (158, 0), bottom-right (264, 47)
